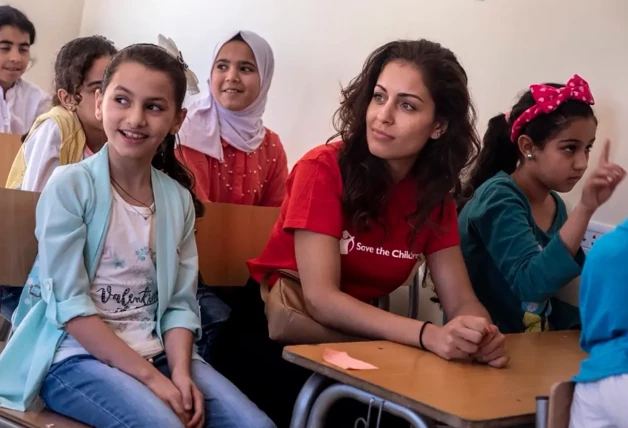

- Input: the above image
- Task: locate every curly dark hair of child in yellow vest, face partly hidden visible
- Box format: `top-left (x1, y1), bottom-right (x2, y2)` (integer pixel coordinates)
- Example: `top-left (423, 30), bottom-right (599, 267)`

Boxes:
top-left (52, 36), bottom-right (117, 106)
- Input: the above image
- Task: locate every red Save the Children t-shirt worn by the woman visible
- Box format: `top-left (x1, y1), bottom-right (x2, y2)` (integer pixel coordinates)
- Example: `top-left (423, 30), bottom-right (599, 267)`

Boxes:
top-left (248, 142), bottom-right (460, 301)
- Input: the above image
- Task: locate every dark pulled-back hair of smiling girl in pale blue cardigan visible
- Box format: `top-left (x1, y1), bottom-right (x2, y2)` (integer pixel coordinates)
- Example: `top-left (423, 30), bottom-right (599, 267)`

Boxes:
top-left (102, 43), bottom-right (205, 217)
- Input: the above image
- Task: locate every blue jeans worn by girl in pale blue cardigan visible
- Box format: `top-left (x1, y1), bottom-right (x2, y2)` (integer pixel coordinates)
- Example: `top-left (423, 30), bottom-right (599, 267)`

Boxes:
top-left (40, 354), bottom-right (275, 428)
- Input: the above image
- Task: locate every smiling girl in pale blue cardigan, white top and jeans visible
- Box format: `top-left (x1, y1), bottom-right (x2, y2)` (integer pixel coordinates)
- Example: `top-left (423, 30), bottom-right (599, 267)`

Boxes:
top-left (0, 44), bottom-right (274, 428)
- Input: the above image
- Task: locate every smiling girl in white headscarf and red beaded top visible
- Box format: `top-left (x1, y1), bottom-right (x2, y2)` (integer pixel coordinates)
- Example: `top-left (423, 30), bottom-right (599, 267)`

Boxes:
top-left (179, 31), bottom-right (288, 207)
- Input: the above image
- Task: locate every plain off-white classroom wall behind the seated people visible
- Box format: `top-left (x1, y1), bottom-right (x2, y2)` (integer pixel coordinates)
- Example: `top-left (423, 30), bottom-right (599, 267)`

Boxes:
top-left (79, 0), bottom-right (628, 224)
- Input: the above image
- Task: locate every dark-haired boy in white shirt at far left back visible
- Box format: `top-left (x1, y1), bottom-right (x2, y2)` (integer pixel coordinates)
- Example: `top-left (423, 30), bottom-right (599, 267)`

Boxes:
top-left (0, 6), bottom-right (50, 135)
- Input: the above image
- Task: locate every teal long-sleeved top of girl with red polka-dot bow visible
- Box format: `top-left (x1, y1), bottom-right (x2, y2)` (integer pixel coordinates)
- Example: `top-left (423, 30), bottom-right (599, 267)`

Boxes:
top-left (458, 172), bottom-right (584, 333)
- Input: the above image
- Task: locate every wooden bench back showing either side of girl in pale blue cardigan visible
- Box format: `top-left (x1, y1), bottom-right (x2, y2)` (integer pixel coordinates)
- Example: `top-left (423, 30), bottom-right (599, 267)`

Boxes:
top-left (0, 193), bottom-right (279, 287)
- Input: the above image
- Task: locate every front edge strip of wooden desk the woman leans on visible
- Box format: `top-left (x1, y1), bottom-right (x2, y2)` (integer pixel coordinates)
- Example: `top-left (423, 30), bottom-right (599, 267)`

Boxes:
top-left (282, 345), bottom-right (535, 428)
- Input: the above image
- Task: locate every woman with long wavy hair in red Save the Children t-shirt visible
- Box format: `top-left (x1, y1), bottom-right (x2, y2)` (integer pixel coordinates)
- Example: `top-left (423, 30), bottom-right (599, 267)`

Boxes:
top-left (214, 40), bottom-right (508, 426)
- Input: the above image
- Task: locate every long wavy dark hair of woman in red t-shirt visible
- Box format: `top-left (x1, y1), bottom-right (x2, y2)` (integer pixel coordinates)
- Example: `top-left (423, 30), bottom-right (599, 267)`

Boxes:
top-left (330, 40), bottom-right (480, 241)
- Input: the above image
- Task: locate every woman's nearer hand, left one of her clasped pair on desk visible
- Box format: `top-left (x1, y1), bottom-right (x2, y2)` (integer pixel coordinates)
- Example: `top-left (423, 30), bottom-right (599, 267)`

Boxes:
top-left (423, 315), bottom-right (490, 360)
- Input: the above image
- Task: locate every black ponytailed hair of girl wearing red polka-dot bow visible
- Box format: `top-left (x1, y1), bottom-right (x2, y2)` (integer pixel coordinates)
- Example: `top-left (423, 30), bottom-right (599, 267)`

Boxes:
top-left (458, 83), bottom-right (595, 210)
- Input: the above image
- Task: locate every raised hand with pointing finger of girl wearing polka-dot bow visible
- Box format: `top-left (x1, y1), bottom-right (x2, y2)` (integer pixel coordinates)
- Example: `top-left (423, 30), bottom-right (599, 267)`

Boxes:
top-left (580, 140), bottom-right (626, 213)
